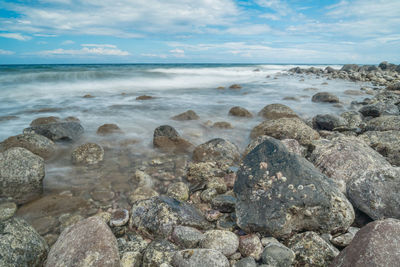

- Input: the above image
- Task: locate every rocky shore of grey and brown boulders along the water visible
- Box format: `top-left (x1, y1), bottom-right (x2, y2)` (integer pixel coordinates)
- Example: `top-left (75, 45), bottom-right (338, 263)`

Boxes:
top-left (0, 62), bottom-right (400, 267)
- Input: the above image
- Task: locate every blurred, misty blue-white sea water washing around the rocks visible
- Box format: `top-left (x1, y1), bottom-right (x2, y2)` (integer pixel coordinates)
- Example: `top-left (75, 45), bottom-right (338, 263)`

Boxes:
top-left (0, 64), bottom-right (369, 203)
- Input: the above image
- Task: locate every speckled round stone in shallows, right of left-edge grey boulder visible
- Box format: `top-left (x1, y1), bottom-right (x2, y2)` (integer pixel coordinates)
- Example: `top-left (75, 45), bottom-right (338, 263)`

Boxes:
top-left (71, 143), bottom-right (104, 165)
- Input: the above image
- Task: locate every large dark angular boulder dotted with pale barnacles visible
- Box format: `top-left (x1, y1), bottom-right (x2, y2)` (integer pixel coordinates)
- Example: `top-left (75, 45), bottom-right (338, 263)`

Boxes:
top-left (234, 139), bottom-right (354, 238)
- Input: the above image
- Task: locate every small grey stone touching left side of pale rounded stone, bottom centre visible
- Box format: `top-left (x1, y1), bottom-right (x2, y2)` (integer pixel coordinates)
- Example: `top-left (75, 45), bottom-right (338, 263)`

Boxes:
top-left (171, 225), bottom-right (204, 248)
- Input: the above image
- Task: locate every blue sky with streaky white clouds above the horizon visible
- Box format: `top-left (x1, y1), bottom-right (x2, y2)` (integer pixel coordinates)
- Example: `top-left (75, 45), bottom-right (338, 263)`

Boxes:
top-left (0, 0), bottom-right (400, 64)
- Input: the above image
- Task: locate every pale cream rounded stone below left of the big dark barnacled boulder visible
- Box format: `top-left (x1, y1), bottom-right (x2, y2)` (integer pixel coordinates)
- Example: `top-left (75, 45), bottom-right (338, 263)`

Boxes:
top-left (201, 230), bottom-right (239, 256)
